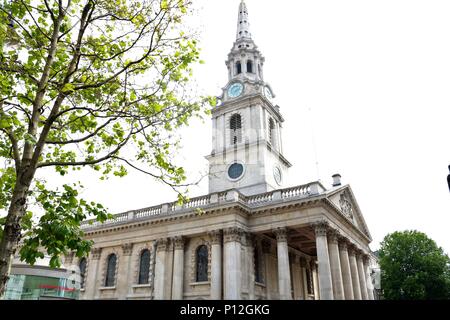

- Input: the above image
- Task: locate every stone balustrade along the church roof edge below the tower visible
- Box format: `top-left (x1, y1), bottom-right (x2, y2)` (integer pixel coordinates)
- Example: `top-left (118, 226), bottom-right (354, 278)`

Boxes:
top-left (81, 182), bottom-right (326, 229)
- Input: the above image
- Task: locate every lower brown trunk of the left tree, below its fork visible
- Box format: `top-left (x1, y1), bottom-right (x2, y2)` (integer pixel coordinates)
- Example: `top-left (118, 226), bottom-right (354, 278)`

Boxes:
top-left (0, 170), bottom-right (35, 297)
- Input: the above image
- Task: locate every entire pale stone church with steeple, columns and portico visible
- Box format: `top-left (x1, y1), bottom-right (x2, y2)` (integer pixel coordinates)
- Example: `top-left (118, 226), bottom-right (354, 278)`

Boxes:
top-left (65, 1), bottom-right (375, 300)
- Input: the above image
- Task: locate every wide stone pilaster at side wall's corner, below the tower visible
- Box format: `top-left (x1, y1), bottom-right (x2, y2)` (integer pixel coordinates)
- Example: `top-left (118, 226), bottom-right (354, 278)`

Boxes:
top-left (224, 228), bottom-right (242, 300)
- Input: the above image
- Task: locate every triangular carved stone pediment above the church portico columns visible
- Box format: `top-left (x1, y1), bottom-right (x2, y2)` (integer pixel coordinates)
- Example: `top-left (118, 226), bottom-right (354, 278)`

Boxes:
top-left (327, 185), bottom-right (372, 239)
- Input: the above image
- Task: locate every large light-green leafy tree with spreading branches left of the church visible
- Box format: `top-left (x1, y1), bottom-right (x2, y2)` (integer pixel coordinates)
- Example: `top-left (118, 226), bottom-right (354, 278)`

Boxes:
top-left (0, 0), bottom-right (213, 295)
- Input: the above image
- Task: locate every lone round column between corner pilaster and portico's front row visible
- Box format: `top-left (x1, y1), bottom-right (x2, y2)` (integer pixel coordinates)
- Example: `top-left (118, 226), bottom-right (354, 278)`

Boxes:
top-left (273, 228), bottom-right (292, 300)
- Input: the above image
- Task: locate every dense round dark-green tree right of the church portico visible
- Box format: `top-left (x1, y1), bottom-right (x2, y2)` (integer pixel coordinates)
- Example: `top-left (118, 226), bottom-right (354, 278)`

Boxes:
top-left (379, 231), bottom-right (450, 300)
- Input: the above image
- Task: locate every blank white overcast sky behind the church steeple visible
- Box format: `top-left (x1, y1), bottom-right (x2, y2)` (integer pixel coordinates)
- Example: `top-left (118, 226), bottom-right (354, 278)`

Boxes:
top-left (4, 0), bottom-right (450, 253)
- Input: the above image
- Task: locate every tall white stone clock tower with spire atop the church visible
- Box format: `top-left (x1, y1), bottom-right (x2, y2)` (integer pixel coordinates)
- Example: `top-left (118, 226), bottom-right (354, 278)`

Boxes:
top-left (207, 0), bottom-right (291, 195)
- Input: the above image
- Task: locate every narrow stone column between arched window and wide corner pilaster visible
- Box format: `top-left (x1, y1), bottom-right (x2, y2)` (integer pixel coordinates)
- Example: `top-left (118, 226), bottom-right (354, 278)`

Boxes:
top-left (209, 230), bottom-right (222, 300)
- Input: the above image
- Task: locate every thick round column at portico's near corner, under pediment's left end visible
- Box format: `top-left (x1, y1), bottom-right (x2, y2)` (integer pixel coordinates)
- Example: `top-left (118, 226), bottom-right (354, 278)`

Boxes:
top-left (313, 222), bottom-right (334, 300)
